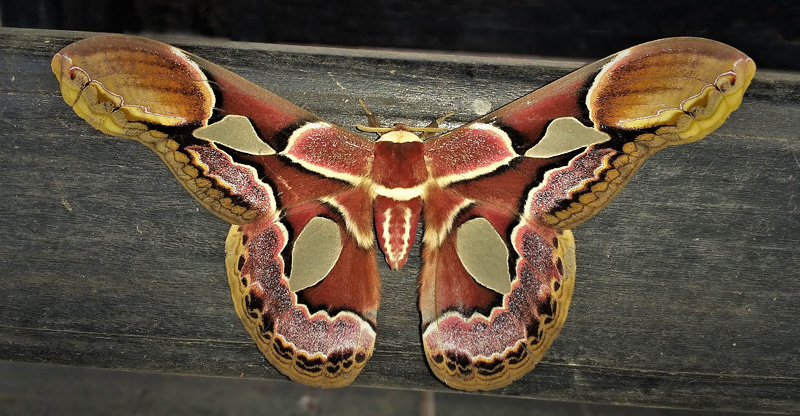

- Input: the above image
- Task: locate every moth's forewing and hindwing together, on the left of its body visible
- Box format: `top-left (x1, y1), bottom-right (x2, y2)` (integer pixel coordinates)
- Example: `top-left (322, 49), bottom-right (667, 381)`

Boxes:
top-left (52, 35), bottom-right (378, 386)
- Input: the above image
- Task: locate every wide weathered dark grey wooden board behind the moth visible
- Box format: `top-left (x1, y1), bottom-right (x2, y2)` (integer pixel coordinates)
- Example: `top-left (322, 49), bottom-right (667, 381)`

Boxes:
top-left (0, 29), bottom-right (800, 413)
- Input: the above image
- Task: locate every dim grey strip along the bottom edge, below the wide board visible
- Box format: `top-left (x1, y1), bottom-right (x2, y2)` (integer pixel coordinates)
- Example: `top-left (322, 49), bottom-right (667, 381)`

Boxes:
top-left (0, 361), bottom-right (780, 416)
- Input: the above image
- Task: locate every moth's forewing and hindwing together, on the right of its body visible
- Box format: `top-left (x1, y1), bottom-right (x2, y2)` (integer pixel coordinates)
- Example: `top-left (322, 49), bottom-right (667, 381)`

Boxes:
top-left (420, 38), bottom-right (755, 390)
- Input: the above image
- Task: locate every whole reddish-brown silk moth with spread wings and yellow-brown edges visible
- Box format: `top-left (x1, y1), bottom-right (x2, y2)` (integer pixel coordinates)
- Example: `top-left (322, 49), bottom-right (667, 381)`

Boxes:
top-left (52, 35), bottom-right (755, 390)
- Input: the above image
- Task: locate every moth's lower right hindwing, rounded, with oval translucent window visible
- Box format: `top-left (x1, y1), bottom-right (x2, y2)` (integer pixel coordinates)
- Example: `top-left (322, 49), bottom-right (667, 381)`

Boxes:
top-left (419, 190), bottom-right (575, 390)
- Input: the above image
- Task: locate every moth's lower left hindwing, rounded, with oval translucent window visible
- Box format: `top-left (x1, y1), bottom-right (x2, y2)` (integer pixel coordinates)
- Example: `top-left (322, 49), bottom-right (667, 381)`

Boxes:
top-left (226, 188), bottom-right (379, 387)
